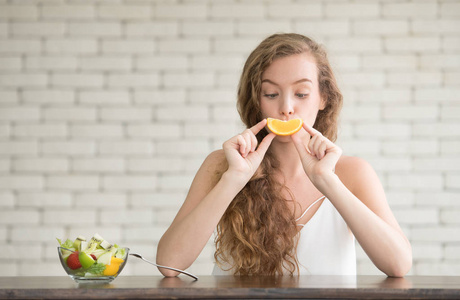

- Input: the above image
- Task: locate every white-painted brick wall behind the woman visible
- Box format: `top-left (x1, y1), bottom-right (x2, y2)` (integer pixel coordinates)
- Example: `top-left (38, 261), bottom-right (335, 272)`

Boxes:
top-left (0, 0), bottom-right (460, 276)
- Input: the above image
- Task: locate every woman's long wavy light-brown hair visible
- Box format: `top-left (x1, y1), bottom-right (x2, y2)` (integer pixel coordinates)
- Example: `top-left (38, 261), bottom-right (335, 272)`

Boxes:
top-left (214, 33), bottom-right (342, 275)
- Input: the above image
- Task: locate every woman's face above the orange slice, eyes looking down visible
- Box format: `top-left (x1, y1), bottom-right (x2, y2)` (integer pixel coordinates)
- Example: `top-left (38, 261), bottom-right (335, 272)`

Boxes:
top-left (260, 53), bottom-right (325, 132)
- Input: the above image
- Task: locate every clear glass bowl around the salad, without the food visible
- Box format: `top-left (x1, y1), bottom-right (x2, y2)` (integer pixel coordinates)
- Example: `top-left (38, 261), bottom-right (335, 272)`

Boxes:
top-left (57, 247), bottom-right (129, 284)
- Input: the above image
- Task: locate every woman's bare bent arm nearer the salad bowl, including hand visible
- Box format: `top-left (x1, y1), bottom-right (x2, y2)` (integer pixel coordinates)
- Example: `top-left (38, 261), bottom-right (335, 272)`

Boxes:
top-left (157, 120), bottom-right (274, 276)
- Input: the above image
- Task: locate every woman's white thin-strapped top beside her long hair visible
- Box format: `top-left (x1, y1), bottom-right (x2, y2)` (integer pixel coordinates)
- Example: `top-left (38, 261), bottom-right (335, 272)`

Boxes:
top-left (212, 196), bottom-right (356, 275)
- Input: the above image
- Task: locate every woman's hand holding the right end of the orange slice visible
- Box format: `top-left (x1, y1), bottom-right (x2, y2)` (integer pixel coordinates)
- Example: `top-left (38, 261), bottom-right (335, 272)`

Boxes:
top-left (291, 123), bottom-right (342, 183)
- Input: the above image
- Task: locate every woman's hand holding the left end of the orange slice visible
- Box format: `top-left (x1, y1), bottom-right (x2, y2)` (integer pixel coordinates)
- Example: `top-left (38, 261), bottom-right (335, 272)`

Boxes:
top-left (223, 119), bottom-right (275, 184)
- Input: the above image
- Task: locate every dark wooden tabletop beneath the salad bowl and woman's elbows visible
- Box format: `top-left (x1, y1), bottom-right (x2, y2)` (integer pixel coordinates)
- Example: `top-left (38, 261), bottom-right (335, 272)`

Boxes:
top-left (0, 275), bottom-right (460, 299)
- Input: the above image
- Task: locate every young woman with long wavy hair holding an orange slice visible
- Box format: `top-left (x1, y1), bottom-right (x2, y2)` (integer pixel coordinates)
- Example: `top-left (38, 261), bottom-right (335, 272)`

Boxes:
top-left (157, 34), bottom-right (412, 276)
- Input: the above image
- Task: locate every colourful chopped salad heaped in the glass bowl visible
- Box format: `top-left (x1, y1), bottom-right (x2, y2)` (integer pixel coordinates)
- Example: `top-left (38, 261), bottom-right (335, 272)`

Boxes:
top-left (57, 233), bottom-right (127, 278)
